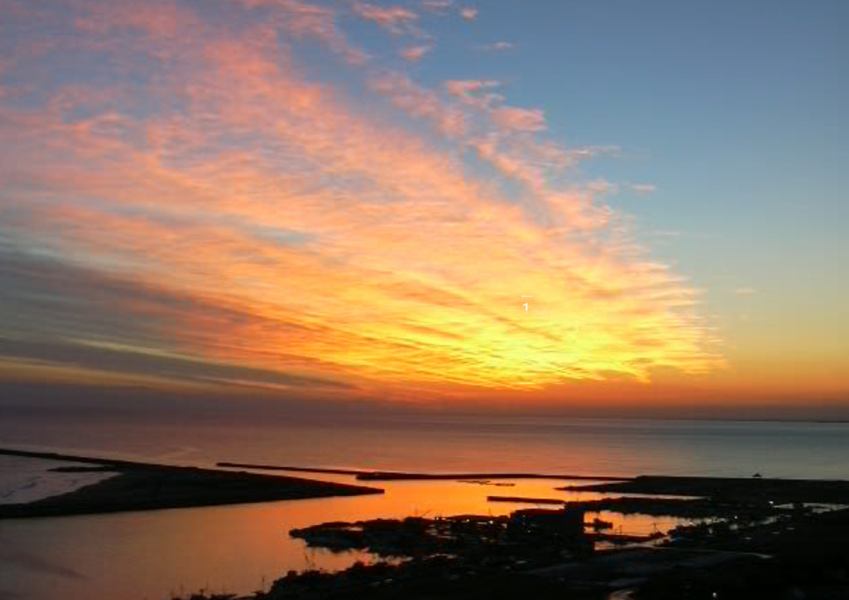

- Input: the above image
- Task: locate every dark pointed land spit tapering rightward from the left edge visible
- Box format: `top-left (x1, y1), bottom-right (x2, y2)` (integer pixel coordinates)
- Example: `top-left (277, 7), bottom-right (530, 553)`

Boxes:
top-left (0, 448), bottom-right (383, 519)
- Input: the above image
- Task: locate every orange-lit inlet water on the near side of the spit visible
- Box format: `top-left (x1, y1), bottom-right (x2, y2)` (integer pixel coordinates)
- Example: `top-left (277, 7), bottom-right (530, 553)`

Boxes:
top-left (0, 476), bottom-right (679, 600)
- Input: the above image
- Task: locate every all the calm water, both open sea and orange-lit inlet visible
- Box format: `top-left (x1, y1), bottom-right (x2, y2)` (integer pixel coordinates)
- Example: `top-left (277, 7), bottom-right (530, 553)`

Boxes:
top-left (0, 418), bottom-right (849, 600)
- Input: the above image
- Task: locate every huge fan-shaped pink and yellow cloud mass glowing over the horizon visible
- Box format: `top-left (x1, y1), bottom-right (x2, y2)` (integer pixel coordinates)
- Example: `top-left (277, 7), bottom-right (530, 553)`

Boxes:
top-left (0, 0), bottom-right (721, 404)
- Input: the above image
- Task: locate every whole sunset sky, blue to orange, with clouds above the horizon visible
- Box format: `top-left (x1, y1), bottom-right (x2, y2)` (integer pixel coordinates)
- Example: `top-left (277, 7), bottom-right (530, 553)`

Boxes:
top-left (0, 0), bottom-right (849, 415)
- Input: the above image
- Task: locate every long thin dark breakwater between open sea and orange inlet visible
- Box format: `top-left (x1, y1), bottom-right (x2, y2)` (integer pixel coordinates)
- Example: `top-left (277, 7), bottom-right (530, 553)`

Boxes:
top-left (216, 462), bottom-right (631, 481)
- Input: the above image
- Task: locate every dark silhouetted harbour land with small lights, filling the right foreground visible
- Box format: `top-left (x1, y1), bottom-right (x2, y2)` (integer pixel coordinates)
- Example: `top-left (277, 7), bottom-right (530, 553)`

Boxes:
top-left (174, 477), bottom-right (849, 600)
